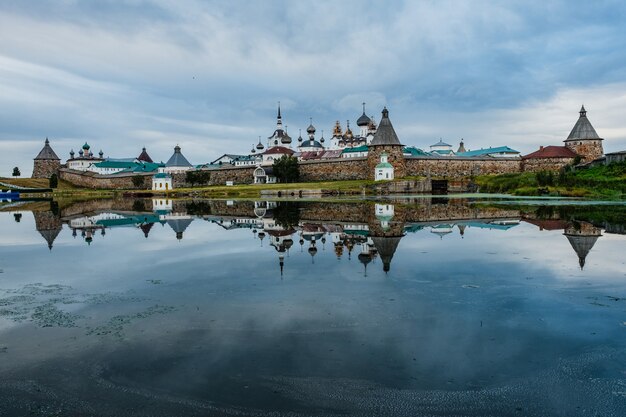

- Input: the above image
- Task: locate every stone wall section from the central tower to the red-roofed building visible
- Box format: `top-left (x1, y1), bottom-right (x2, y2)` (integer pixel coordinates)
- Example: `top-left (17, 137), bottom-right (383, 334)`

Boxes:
top-left (406, 157), bottom-right (521, 178)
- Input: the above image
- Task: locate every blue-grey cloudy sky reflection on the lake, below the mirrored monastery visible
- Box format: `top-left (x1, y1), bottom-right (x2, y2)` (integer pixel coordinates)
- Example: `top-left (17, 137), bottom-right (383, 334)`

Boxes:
top-left (0, 205), bottom-right (626, 414)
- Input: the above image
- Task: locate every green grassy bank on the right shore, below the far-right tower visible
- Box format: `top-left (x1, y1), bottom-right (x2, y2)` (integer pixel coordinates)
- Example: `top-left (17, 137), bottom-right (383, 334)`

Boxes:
top-left (475, 162), bottom-right (626, 199)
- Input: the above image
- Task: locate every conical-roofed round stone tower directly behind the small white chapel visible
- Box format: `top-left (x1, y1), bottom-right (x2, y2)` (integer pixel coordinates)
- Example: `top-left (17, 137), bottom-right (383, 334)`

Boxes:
top-left (367, 107), bottom-right (406, 180)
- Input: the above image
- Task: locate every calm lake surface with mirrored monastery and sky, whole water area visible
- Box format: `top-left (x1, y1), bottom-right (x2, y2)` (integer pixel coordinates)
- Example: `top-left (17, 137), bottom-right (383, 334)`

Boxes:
top-left (0, 198), bottom-right (626, 416)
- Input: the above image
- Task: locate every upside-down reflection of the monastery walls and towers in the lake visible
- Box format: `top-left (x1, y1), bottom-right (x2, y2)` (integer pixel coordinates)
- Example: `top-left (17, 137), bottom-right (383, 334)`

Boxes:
top-left (7, 199), bottom-right (619, 275)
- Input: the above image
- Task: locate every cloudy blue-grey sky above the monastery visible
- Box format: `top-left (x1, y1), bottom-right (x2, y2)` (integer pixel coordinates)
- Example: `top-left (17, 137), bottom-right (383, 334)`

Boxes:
top-left (0, 0), bottom-right (626, 176)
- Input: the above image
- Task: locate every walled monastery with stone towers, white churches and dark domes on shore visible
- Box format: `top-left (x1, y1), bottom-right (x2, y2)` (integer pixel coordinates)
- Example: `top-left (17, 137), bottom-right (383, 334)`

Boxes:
top-left (33, 103), bottom-right (614, 191)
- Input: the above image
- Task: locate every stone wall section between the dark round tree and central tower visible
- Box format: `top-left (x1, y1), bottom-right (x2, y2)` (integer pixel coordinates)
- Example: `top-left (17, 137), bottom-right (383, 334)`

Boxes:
top-left (299, 158), bottom-right (366, 182)
